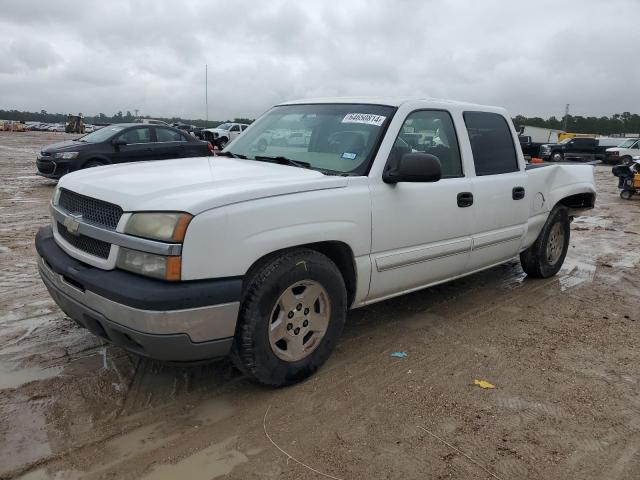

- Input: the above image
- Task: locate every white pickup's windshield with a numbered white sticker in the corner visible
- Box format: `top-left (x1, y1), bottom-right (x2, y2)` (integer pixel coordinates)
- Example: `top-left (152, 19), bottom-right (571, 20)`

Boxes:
top-left (225, 104), bottom-right (395, 175)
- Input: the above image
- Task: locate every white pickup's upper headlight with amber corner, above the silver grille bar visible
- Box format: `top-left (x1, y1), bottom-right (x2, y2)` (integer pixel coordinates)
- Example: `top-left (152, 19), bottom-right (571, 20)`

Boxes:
top-left (124, 212), bottom-right (193, 243)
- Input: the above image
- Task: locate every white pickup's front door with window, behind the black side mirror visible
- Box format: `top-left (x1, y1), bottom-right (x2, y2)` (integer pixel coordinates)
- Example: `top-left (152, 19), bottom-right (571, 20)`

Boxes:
top-left (369, 110), bottom-right (473, 300)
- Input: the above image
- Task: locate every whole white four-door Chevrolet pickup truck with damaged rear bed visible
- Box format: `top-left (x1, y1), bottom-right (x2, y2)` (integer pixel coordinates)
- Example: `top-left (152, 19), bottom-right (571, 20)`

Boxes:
top-left (36, 98), bottom-right (596, 386)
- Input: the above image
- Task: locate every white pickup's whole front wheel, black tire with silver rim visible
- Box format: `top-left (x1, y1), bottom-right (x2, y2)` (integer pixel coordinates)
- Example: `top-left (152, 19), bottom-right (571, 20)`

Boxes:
top-left (231, 249), bottom-right (347, 387)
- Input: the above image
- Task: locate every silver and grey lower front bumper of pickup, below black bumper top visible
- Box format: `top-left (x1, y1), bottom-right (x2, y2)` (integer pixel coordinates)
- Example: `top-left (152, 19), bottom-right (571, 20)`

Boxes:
top-left (38, 259), bottom-right (239, 362)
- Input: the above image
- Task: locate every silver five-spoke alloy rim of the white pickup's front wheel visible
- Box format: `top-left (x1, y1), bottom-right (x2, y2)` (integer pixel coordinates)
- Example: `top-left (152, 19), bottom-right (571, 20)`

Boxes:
top-left (269, 280), bottom-right (331, 362)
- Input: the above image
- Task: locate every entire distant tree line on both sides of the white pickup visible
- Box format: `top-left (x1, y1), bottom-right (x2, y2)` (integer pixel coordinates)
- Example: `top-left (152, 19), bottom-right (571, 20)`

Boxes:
top-left (0, 110), bottom-right (640, 135)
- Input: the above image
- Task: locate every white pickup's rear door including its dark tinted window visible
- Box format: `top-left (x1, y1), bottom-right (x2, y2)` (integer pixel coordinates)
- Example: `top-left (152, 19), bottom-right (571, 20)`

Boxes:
top-left (463, 111), bottom-right (529, 271)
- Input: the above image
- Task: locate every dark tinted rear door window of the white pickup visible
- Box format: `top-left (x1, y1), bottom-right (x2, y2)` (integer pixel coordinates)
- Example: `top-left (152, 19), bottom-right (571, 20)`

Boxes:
top-left (464, 112), bottom-right (520, 176)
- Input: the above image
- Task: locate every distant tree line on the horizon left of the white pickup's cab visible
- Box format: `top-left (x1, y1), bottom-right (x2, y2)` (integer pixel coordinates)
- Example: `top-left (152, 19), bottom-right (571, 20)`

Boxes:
top-left (0, 109), bottom-right (253, 128)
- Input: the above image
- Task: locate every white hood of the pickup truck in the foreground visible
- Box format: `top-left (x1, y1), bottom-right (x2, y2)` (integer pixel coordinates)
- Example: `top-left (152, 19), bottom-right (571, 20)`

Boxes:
top-left (58, 157), bottom-right (348, 215)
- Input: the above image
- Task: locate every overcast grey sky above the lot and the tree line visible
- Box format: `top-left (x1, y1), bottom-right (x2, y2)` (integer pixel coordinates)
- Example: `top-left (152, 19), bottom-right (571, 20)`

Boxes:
top-left (0, 0), bottom-right (640, 119)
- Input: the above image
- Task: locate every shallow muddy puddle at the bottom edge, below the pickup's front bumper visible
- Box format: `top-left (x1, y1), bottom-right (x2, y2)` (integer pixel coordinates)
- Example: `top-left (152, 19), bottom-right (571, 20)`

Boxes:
top-left (143, 437), bottom-right (249, 480)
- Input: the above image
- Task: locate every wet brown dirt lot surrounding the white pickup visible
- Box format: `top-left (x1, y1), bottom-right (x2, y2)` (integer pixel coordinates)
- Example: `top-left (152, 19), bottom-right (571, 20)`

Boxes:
top-left (0, 132), bottom-right (640, 480)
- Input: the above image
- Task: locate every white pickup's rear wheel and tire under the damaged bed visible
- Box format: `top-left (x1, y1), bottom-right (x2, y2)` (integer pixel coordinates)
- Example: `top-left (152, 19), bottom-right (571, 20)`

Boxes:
top-left (520, 206), bottom-right (571, 278)
